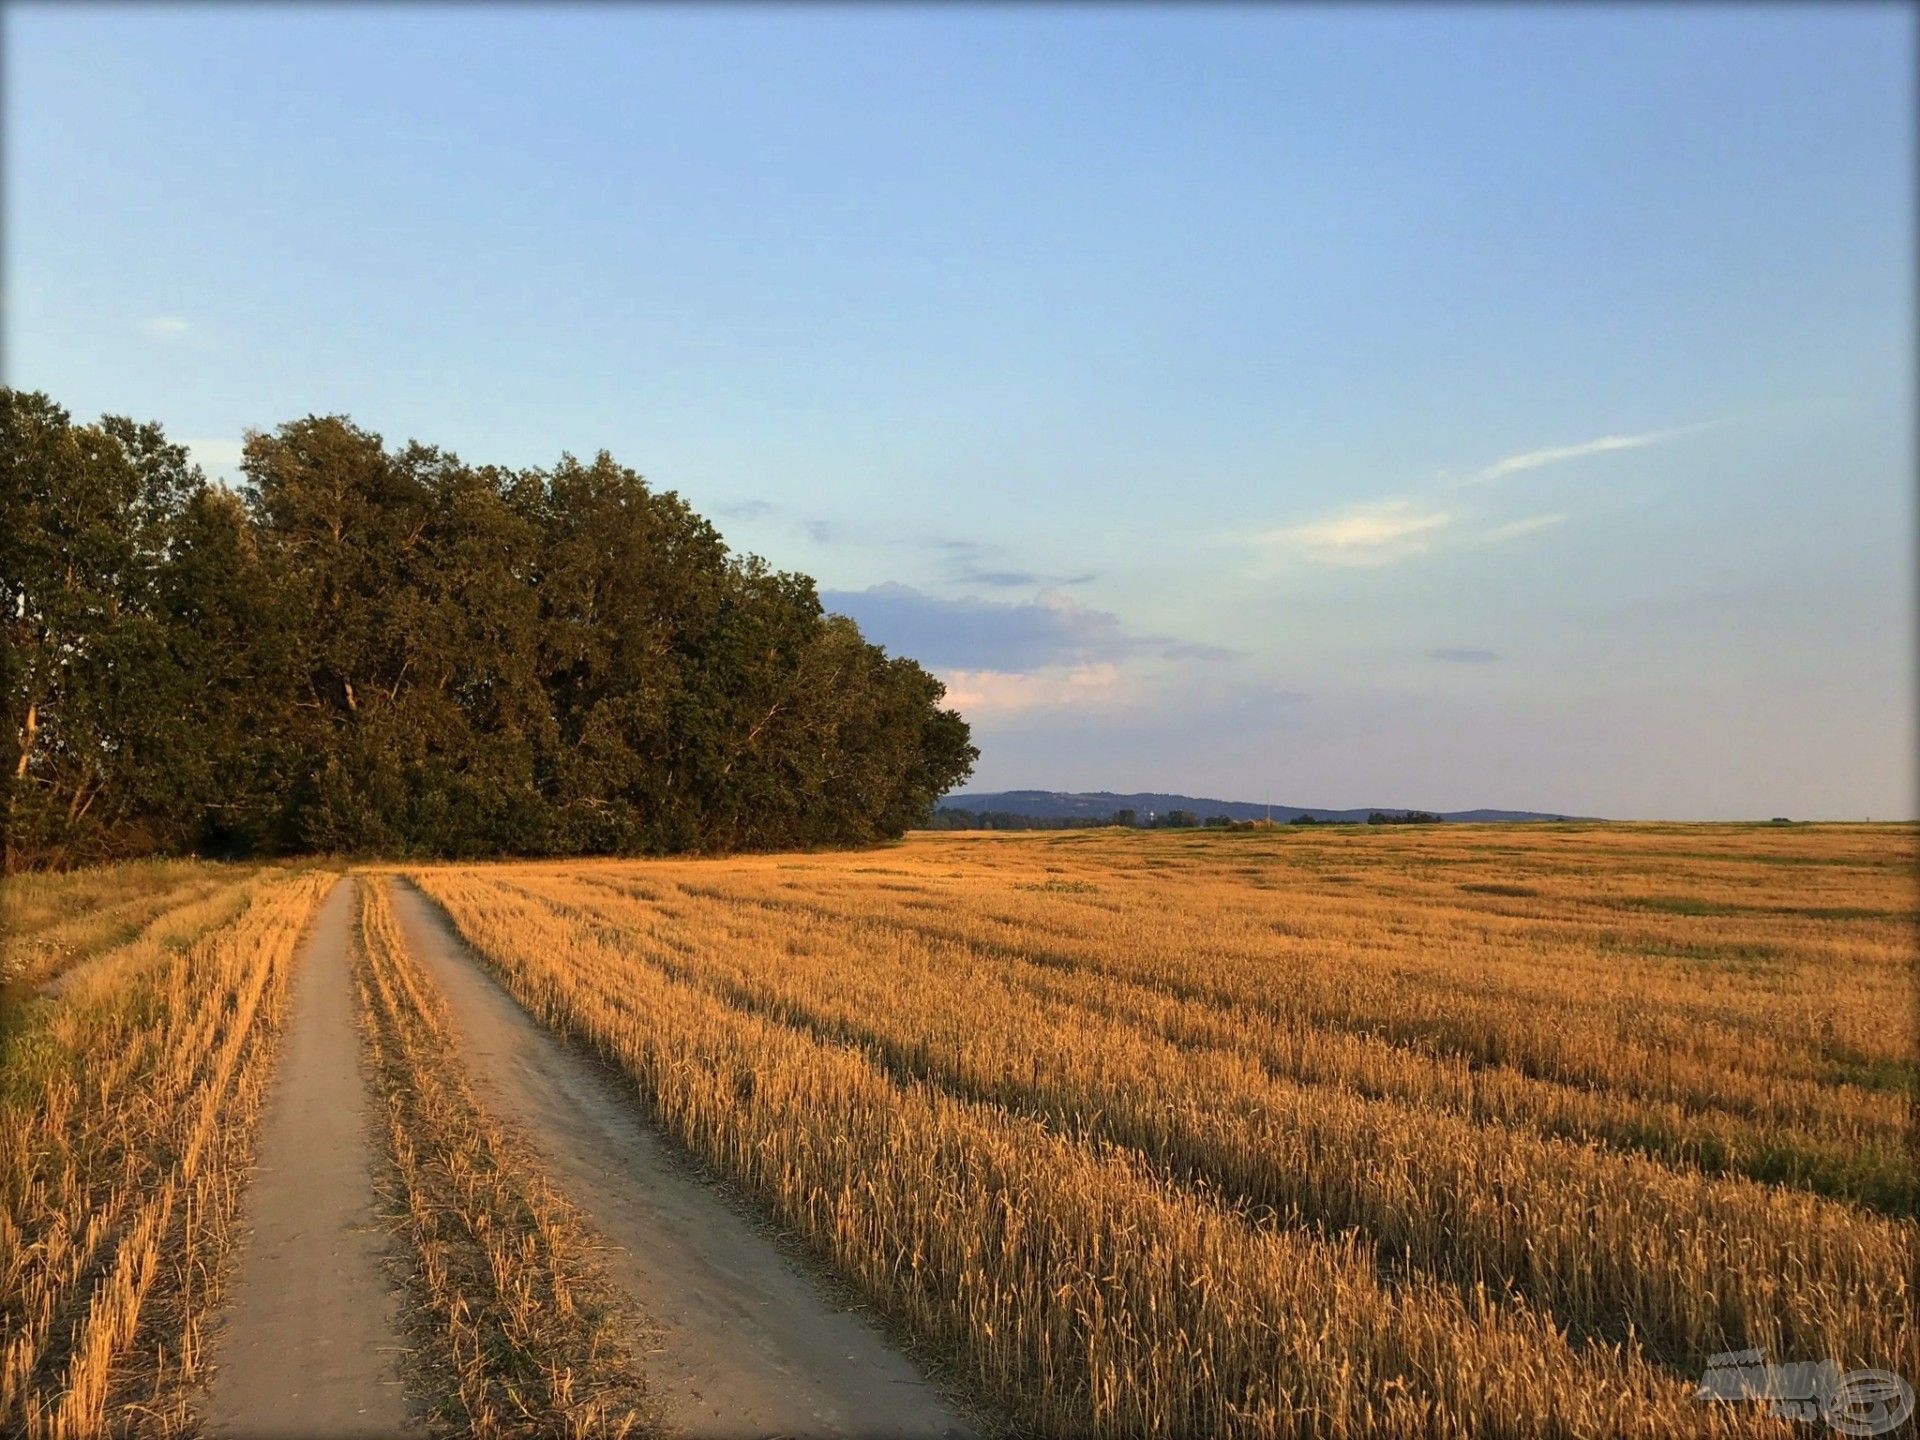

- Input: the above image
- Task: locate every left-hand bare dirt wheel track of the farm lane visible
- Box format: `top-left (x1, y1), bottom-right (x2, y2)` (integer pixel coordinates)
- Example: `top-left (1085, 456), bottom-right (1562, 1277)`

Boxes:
top-left (205, 879), bottom-right (409, 1440)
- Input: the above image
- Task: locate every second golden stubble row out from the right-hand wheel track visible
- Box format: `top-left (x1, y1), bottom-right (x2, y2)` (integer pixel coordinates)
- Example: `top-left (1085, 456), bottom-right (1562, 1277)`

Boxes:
top-left (476, 856), bottom-right (1912, 1367)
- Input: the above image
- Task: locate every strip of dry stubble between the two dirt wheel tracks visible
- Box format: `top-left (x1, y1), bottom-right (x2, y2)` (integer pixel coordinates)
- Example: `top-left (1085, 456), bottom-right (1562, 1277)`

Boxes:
top-left (355, 877), bottom-right (649, 1438)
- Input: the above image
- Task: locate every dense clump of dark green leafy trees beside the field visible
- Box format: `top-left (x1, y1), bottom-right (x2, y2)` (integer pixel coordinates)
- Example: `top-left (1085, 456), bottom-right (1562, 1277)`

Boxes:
top-left (0, 390), bottom-right (977, 870)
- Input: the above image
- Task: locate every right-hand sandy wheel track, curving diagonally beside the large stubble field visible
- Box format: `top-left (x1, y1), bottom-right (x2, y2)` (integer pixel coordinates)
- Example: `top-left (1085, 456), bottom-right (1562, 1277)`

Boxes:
top-left (394, 881), bottom-right (975, 1440)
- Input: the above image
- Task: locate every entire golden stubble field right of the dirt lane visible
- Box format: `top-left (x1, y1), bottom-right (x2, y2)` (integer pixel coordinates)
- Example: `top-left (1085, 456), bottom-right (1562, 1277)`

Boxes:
top-left (417, 826), bottom-right (1916, 1434)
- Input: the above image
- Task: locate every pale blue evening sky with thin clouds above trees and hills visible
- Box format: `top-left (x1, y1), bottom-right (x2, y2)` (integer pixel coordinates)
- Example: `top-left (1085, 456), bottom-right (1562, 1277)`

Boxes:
top-left (4, 4), bottom-right (1916, 818)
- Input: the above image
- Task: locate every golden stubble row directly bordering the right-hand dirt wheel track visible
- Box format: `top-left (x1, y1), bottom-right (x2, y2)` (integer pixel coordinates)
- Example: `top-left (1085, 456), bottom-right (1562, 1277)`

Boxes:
top-left (417, 845), bottom-right (1873, 1434)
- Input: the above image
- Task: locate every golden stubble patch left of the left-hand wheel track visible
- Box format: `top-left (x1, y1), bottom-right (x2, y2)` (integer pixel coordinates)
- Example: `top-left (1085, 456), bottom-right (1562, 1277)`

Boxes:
top-left (0, 872), bottom-right (332, 1440)
